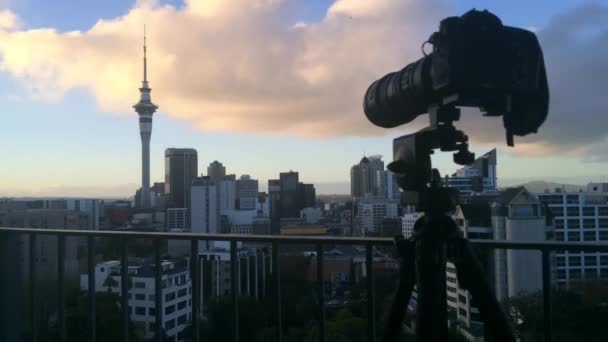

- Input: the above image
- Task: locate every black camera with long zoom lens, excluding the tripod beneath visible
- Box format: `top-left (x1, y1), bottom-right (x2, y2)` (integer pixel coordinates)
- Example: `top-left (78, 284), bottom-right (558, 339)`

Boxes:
top-left (364, 10), bottom-right (549, 144)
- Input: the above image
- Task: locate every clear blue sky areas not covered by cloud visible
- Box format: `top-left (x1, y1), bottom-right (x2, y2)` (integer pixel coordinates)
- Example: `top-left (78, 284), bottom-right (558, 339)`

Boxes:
top-left (0, 0), bottom-right (608, 196)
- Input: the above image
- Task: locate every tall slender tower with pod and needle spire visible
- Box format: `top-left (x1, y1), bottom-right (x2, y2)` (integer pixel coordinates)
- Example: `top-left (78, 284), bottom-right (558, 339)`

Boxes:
top-left (133, 32), bottom-right (158, 209)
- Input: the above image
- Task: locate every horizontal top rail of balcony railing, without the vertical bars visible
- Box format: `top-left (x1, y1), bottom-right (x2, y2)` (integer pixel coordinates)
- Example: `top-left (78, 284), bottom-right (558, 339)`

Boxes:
top-left (0, 227), bottom-right (608, 252)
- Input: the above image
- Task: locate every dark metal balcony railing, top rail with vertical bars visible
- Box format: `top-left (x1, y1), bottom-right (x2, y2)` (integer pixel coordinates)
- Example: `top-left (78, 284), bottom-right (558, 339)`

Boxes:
top-left (0, 227), bottom-right (608, 342)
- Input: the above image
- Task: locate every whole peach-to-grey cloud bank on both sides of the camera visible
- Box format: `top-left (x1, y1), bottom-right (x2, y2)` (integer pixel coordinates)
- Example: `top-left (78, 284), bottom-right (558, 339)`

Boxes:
top-left (0, 0), bottom-right (608, 161)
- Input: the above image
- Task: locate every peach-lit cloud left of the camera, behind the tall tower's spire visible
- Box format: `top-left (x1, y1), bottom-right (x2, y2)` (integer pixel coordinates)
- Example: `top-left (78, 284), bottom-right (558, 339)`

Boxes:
top-left (0, 0), bottom-right (444, 136)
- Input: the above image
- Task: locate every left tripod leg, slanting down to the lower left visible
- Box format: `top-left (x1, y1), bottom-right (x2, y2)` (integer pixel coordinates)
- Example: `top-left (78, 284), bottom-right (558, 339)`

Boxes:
top-left (382, 238), bottom-right (415, 342)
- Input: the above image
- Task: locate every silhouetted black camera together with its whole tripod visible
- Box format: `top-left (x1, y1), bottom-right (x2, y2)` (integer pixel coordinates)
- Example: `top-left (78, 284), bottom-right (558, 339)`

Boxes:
top-left (363, 10), bottom-right (549, 342)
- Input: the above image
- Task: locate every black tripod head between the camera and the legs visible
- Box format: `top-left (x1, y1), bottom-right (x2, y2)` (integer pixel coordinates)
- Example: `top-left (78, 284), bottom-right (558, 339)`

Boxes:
top-left (387, 104), bottom-right (475, 213)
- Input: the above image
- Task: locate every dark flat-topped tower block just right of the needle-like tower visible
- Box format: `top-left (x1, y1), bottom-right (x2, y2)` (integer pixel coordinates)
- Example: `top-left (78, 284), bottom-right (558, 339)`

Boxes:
top-left (165, 148), bottom-right (198, 208)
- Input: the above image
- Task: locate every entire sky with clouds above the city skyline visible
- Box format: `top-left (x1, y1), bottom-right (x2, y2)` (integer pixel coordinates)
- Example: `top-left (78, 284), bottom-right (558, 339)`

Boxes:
top-left (0, 0), bottom-right (608, 197)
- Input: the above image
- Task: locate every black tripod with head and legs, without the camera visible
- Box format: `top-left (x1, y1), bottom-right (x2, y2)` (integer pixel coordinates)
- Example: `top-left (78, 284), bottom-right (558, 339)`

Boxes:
top-left (383, 105), bottom-right (515, 342)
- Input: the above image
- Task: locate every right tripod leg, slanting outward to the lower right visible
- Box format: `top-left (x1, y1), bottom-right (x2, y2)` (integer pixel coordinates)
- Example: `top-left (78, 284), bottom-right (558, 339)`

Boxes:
top-left (453, 238), bottom-right (516, 342)
